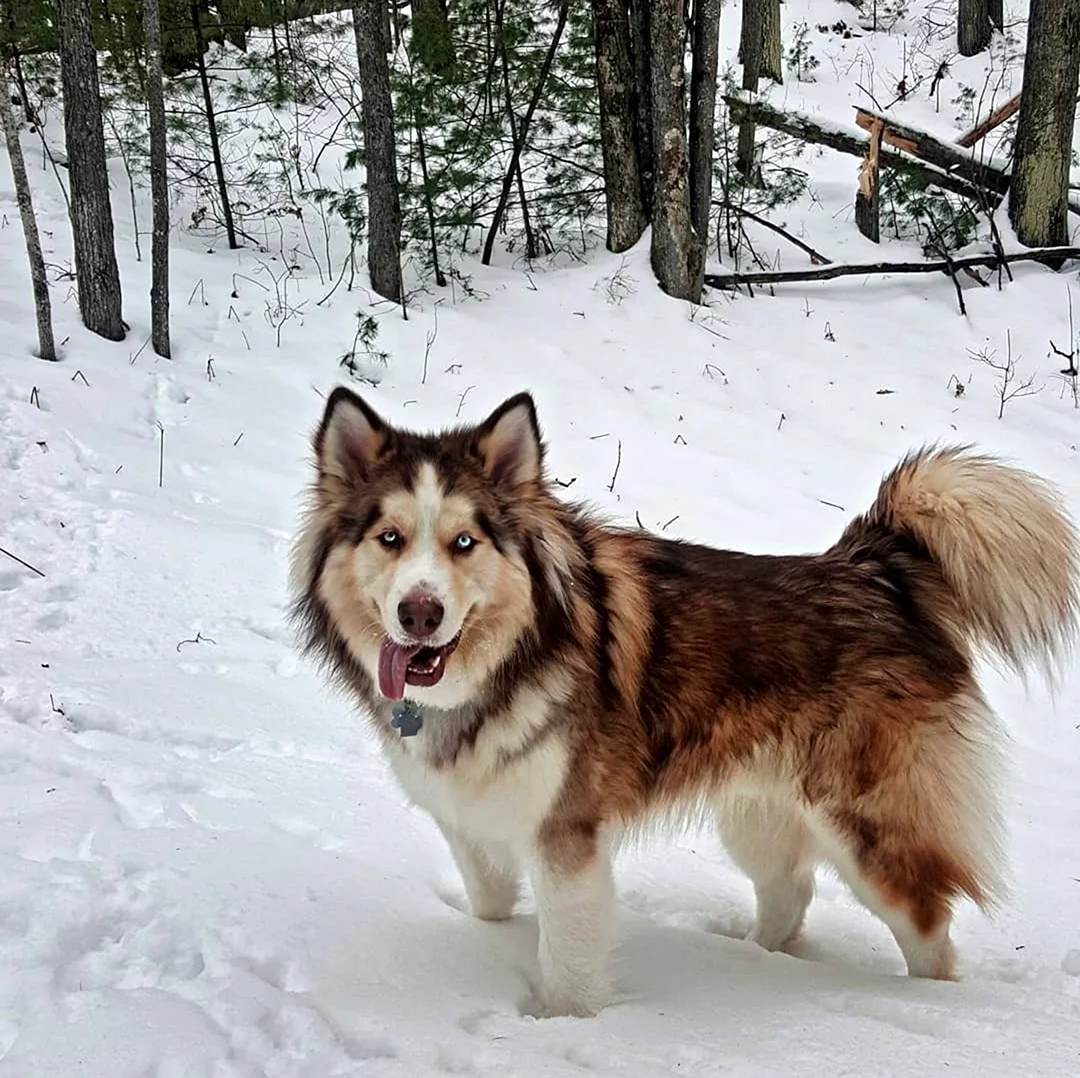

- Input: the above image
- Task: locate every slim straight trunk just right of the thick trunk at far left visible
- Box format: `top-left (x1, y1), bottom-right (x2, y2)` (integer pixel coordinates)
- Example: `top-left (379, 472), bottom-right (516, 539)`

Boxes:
top-left (143, 0), bottom-right (172, 359)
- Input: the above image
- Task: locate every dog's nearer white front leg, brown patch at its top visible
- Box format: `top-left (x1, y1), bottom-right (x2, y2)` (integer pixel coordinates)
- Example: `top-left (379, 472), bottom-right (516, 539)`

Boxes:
top-left (532, 828), bottom-right (615, 1018)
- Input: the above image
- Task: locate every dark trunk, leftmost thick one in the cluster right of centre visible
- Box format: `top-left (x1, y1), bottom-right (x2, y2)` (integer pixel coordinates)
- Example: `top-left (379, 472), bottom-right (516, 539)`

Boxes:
top-left (593, 0), bottom-right (643, 254)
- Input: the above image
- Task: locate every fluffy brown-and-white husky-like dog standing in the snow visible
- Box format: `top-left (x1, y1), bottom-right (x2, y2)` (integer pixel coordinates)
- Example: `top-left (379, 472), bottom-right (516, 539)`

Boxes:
top-left (292, 387), bottom-right (1080, 1016)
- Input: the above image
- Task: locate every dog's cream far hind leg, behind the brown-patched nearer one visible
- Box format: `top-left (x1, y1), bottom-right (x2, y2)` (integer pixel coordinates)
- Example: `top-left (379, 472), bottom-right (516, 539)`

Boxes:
top-left (717, 797), bottom-right (814, 951)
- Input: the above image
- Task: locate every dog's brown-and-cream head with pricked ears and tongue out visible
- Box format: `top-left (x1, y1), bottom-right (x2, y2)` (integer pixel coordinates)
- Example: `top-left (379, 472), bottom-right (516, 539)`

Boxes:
top-left (295, 388), bottom-right (544, 708)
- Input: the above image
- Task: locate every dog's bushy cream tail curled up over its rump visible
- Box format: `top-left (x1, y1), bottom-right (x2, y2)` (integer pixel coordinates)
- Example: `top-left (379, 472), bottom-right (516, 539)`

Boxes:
top-left (841, 447), bottom-right (1080, 679)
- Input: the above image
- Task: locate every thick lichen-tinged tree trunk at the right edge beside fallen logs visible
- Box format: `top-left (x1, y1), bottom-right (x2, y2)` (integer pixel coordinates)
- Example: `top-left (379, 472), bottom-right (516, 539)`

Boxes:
top-left (1009, 0), bottom-right (1080, 247)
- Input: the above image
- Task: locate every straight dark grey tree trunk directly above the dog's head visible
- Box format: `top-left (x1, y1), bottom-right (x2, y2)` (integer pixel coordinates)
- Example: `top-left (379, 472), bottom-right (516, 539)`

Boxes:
top-left (352, 0), bottom-right (403, 304)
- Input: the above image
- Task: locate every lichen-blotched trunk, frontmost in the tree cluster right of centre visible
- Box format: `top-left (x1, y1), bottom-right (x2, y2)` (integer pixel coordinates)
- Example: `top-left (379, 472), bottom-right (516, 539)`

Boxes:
top-left (649, 0), bottom-right (704, 304)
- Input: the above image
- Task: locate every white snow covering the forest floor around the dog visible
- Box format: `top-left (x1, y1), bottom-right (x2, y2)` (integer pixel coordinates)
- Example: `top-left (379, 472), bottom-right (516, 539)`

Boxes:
top-left (0, 0), bottom-right (1080, 1078)
